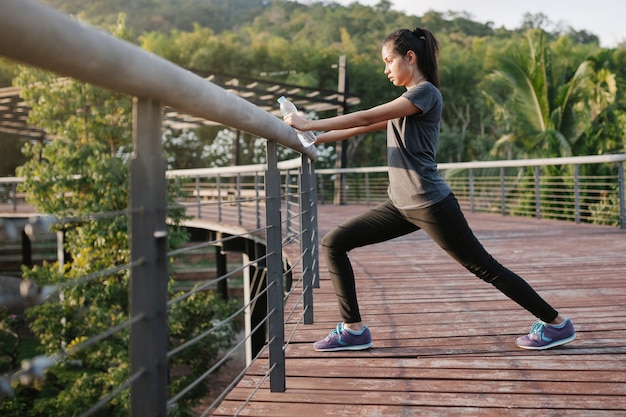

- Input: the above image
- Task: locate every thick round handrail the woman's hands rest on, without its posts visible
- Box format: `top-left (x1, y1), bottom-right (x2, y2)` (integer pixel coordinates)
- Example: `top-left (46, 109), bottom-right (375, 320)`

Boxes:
top-left (0, 0), bottom-right (316, 160)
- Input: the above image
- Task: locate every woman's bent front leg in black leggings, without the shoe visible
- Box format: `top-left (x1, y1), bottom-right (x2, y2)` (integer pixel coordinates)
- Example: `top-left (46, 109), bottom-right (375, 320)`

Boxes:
top-left (322, 201), bottom-right (419, 323)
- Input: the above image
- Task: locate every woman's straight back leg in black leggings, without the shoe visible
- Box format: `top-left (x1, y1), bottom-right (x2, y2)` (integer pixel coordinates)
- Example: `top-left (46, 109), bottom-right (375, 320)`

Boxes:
top-left (405, 194), bottom-right (558, 323)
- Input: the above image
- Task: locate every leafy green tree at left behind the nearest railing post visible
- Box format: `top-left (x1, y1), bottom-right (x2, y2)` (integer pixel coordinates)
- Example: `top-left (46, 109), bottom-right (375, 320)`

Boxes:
top-left (0, 14), bottom-right (235, 417)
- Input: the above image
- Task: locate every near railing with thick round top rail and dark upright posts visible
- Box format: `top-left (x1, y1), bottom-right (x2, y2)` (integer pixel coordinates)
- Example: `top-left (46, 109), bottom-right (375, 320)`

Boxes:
top-left (0, 0), bottom-right (316, 417)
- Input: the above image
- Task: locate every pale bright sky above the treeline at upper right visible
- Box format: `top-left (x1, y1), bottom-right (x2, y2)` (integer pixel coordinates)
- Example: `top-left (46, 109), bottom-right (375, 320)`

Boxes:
top-left (334, 0), bottom-right (626, 48)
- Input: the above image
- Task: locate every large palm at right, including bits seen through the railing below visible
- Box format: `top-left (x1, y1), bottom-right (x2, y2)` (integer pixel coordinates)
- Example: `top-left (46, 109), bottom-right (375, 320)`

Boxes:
top-left (480, 29), bottom-right (617, 221)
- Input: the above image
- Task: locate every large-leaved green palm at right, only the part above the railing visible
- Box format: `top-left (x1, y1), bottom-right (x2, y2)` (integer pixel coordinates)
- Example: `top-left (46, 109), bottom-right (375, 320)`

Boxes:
top-left (490, 30), bottom-right (617, 157)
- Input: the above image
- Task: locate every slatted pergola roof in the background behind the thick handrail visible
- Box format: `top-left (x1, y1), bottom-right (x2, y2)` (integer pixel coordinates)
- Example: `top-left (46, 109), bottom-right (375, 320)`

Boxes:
top-left (0, 75), bottom-right (360, 140)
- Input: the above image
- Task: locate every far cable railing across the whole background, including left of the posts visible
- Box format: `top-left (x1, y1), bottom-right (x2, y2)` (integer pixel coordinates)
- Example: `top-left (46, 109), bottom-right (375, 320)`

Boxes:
top-left (6, 154), bottom-right (626, 229)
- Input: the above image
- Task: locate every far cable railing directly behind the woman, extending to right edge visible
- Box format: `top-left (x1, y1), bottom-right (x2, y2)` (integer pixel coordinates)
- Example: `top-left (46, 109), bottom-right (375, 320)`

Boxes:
top-left (317, 154), bottom-right (626, 229)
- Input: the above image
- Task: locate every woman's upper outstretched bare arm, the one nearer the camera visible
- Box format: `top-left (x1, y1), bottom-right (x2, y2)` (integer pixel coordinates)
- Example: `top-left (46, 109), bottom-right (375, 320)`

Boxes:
top-left (283, 97), bottom-right (421, 132)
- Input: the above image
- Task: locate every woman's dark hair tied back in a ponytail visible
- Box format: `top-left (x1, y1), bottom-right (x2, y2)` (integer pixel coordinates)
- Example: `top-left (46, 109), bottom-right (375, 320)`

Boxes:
top-left (384, 28), bottom-right (440, 88)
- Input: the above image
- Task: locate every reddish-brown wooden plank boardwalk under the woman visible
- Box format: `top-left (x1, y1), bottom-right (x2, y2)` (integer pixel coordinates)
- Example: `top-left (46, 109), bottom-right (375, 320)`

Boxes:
top-left (213, 205), bottom-right (626, 417)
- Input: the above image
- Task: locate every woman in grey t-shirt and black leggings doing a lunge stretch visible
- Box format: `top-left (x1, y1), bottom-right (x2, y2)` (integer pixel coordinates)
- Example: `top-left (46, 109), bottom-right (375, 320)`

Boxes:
top-left (284, 28), bottom-right (576, 351)
